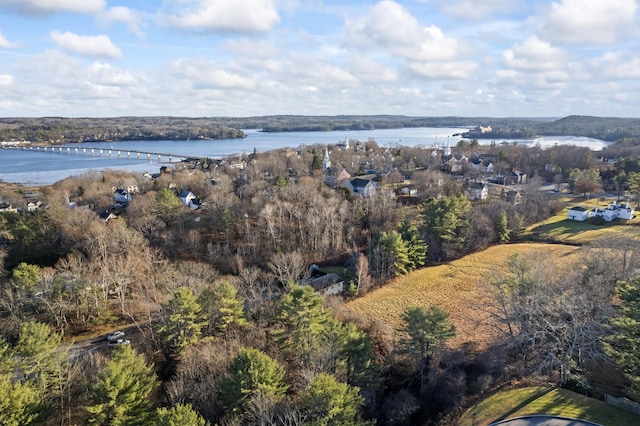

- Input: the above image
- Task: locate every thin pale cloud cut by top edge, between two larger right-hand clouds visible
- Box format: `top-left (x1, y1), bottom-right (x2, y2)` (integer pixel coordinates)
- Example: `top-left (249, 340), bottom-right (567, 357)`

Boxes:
top-left (427, 0), bottom-right (526, 20)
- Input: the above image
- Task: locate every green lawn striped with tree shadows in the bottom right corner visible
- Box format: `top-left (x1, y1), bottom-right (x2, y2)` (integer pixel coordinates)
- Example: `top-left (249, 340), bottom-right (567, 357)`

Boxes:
top-left (458, 386), bottom-right (640, 426)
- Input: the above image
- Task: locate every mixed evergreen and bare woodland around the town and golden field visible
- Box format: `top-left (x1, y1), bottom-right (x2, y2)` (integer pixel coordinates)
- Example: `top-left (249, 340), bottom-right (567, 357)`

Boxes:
top-left (0, 136), bottom-right (640, 425)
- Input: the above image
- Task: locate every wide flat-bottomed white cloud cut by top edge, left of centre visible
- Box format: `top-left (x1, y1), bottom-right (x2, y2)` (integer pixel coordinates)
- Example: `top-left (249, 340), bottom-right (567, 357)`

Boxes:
top-left (160, 0), bottom-right (280, 32)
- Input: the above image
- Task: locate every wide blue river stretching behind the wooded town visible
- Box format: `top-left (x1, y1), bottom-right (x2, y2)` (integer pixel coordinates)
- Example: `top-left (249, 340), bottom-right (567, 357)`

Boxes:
top-left (0, 127), bottom-right (608, 186)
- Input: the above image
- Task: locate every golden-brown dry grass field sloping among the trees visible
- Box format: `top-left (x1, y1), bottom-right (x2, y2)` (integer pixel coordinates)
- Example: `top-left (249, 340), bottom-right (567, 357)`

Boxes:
top-left (345, 243), bottom-right (579, 350)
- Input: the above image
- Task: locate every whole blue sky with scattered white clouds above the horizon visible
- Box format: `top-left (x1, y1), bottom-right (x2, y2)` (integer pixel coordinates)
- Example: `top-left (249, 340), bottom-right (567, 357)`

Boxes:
top-left (0, 0), bottom-right (640, 117)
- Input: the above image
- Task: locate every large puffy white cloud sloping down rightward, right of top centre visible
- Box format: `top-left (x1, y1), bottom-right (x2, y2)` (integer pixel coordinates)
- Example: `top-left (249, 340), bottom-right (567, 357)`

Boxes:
top-left (346, 0), bottom-right (460, 61)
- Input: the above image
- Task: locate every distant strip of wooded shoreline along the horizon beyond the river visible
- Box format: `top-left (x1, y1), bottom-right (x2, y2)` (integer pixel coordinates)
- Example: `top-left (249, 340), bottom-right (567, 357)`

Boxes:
top-left (0, 115), bottom-right (640, 143)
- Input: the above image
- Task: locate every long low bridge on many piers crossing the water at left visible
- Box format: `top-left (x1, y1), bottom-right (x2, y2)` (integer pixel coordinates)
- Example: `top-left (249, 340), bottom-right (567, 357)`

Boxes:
top-left (2, 145), bottom-right (195, 163)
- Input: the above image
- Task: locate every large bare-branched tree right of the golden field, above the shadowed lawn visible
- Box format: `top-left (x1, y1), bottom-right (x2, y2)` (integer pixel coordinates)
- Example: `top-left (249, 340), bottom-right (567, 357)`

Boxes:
top-left (488, 254), bottom-right (611, 384)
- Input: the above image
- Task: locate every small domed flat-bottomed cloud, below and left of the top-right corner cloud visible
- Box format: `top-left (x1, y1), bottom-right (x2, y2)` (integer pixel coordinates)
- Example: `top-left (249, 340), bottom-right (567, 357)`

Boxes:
top-left (503, 36), bottom-right (567, 71)
